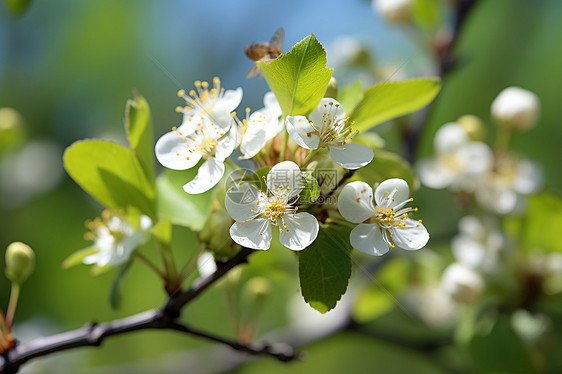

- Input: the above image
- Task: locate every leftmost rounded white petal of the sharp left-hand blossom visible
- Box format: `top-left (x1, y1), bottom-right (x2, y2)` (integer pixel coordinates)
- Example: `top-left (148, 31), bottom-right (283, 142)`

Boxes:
top-left (155, 131), bottom-right (201, 170)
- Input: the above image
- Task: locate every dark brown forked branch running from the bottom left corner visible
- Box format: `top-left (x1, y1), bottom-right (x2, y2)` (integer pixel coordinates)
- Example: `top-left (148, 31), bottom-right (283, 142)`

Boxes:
top-left (0, 248), bottom-right (300, 374)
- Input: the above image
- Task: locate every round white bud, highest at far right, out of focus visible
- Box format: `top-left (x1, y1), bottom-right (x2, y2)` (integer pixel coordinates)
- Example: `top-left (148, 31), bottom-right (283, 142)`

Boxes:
top-left (492, 87), bottom-right (540, 131)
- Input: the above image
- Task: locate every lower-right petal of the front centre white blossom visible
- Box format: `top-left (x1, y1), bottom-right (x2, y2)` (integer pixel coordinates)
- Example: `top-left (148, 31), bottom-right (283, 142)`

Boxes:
top-left (279, 213), bottom-right (318, 251)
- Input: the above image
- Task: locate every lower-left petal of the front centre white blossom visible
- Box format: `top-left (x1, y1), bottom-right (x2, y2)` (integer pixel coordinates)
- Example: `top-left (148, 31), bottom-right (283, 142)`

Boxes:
top-left (230, 218), bottom-right (271, 250)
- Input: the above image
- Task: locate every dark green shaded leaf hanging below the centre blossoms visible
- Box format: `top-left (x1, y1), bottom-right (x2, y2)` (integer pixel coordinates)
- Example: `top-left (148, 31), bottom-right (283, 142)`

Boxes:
top-left (298, 225), bottom-right (351, 313)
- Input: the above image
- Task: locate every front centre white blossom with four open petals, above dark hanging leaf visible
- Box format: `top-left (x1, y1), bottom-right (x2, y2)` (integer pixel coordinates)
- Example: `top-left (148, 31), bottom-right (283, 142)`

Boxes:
top-left (225, 161), bottom-right (318, 251)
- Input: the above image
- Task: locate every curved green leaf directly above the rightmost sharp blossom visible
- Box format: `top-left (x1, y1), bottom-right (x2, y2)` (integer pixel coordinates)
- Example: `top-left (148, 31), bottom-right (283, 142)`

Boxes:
top-left (357, 150), bottom-right (414, 191)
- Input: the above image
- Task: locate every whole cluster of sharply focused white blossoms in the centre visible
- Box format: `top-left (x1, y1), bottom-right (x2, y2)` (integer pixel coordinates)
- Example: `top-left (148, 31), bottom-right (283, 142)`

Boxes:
top-left (156, 78), bottom-right (429, 255)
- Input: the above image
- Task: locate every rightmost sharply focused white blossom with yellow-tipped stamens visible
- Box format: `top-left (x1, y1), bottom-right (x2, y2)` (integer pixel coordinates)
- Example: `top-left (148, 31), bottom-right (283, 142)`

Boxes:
top-left (338, 178), bottom-right (429, 256)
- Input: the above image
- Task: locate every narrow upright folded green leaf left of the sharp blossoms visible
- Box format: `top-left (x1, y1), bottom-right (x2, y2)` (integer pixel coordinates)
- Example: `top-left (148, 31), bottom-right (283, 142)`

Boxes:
top-left (125, 92), bottom-right (154, 183)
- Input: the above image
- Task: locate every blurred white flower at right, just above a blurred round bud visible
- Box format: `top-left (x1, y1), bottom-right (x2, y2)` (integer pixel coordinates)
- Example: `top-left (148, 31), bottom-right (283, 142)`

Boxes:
top-left (451, 216), bottom-right (505, 272)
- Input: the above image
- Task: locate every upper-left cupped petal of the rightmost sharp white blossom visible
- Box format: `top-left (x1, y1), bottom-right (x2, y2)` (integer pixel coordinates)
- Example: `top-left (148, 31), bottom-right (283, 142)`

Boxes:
top-left (338, 181), bottom-right (375, 223)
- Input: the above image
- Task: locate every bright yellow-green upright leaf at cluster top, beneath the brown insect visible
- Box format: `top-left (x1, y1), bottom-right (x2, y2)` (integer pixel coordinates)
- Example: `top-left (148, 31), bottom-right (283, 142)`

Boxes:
top-left (257, 34), bottom-right (333, 116)
